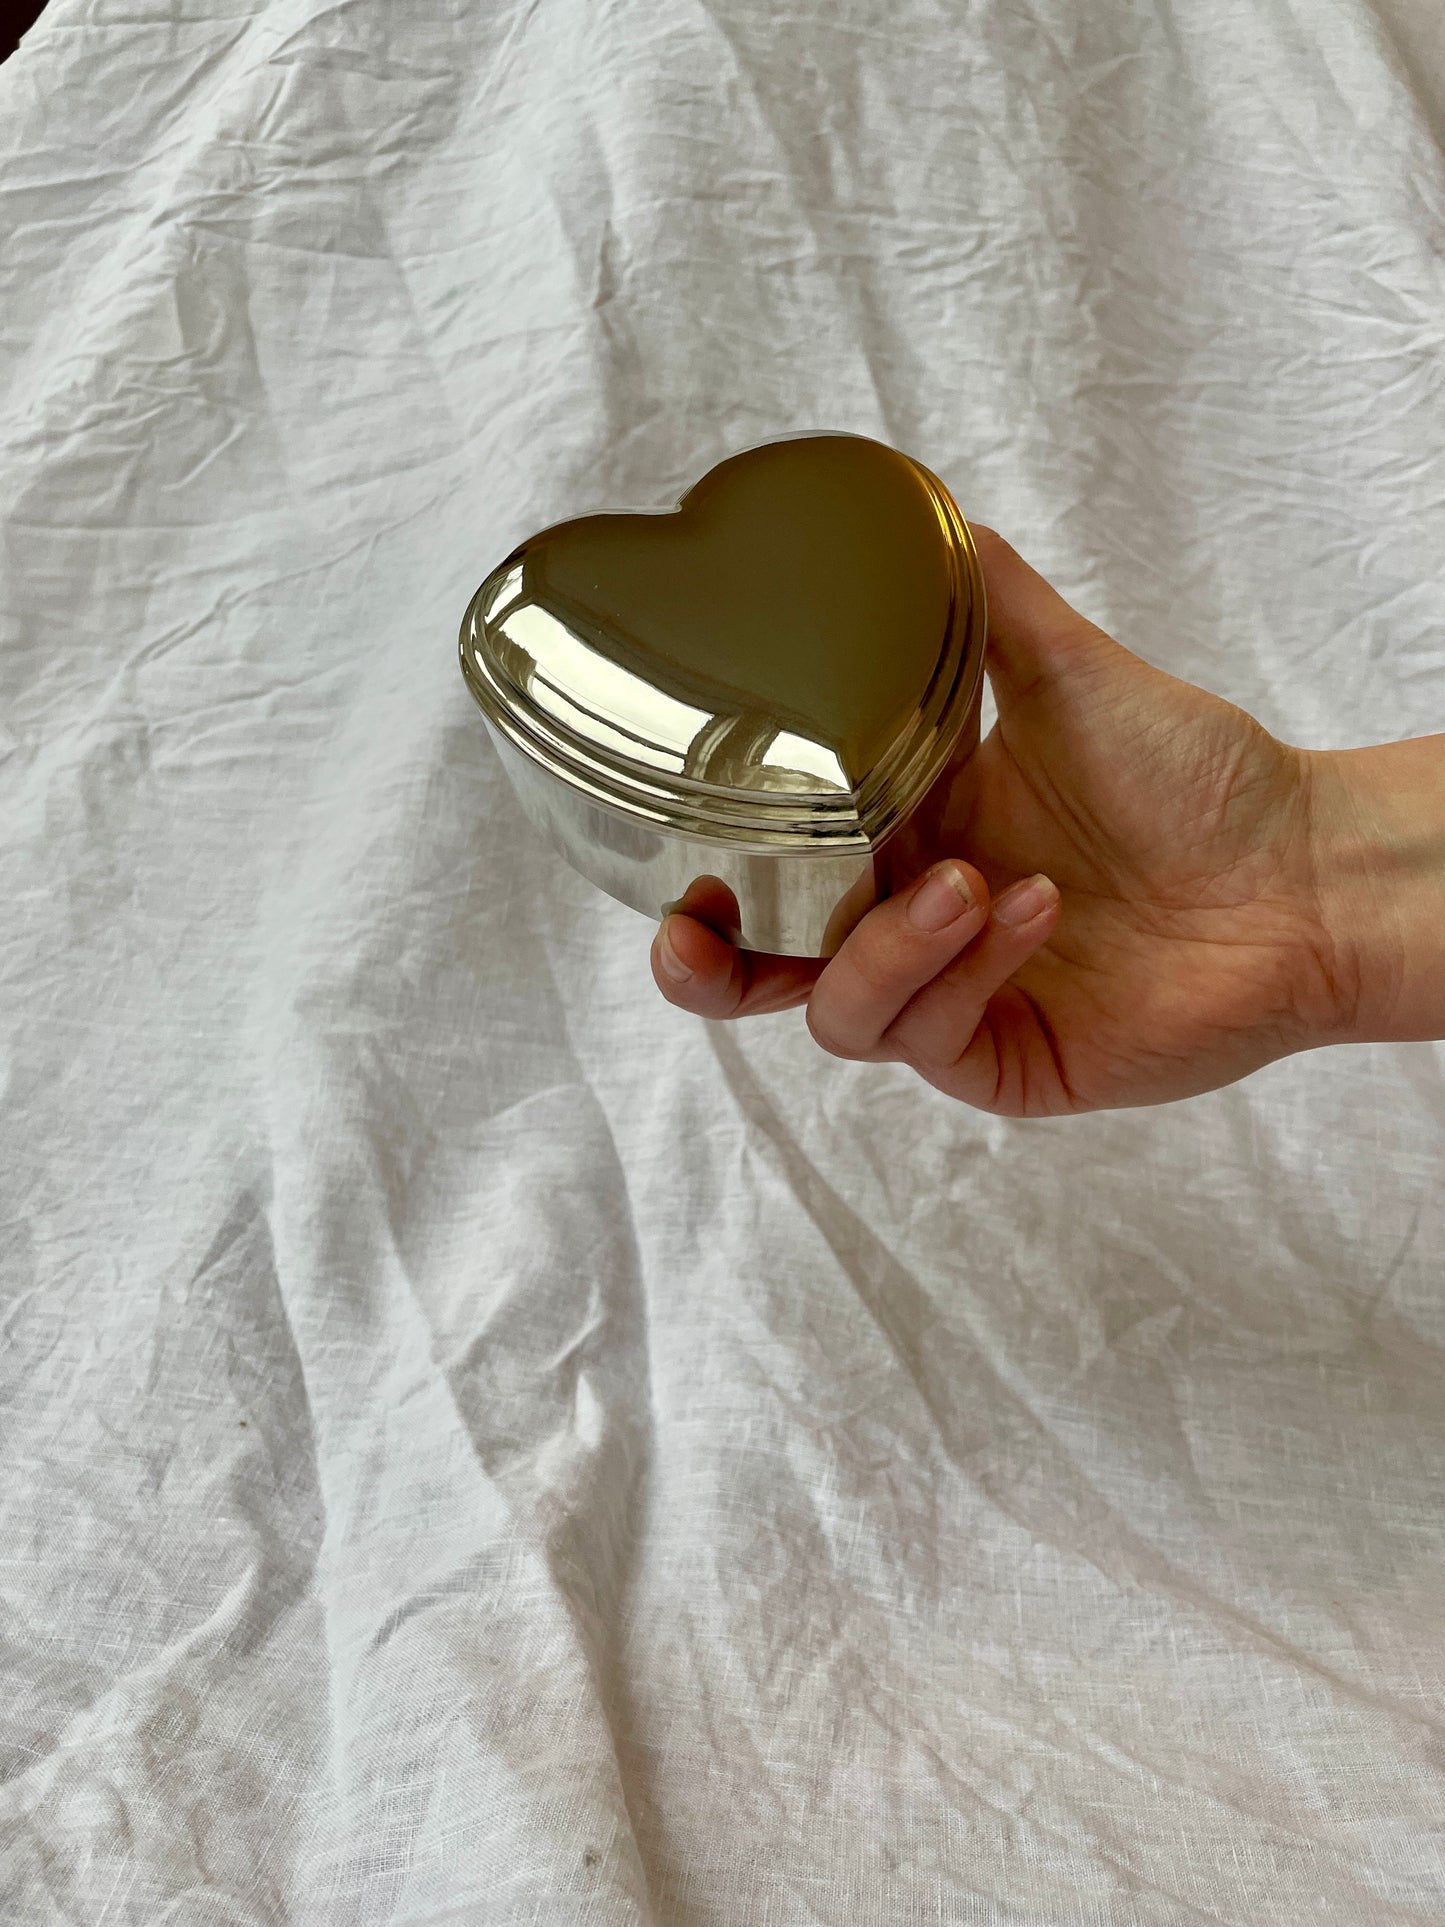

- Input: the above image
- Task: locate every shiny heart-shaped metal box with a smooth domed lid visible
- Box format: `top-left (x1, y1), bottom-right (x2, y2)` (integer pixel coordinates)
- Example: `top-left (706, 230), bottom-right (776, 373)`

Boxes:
top-left (460, 436), bottom-right (985, 956)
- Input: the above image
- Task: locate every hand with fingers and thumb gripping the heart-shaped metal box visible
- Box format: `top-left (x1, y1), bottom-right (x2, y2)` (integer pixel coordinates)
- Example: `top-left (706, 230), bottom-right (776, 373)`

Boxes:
top-left (653, 528), bottom-right (1356, 1116)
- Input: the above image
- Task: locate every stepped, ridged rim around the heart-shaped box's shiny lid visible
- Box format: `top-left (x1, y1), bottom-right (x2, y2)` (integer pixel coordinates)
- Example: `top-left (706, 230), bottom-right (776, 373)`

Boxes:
top-left (460, 437), bottom-right (986, 856)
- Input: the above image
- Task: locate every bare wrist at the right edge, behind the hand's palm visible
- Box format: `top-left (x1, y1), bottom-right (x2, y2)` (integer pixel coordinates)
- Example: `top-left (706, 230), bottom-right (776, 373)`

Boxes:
top-left (1299, 736), bottom-right (1445, 1043)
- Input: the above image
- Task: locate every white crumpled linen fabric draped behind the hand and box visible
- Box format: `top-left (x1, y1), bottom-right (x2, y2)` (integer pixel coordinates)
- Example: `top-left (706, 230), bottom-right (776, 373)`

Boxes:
top-left (0, 0), bottom-right (1445, 1927)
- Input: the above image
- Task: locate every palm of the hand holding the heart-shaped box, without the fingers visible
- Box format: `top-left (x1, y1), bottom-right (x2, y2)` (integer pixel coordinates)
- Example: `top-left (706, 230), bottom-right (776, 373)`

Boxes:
top-left (951, 626), bottom-right (1318, 1112)
